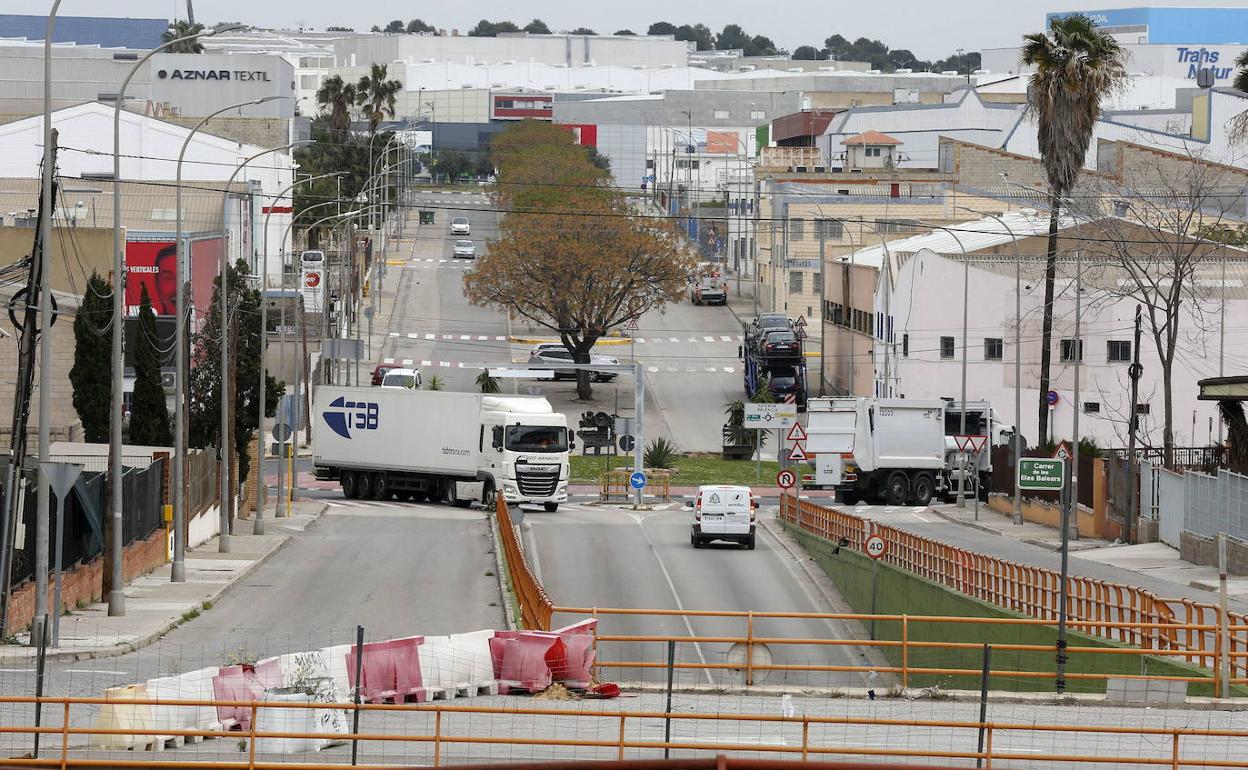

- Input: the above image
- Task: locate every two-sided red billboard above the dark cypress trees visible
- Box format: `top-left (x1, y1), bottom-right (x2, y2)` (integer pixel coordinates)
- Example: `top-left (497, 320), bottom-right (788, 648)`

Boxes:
top-left (126, 238), bottom-right (221, 329)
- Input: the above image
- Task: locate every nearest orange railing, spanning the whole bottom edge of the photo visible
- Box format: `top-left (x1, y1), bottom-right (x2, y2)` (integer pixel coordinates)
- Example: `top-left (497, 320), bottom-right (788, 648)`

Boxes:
top-left (0, 696), bottom-right (1248, 770)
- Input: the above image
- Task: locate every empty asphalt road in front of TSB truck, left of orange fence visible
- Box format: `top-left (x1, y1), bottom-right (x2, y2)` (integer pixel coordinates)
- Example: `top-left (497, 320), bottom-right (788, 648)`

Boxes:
top-left (18, 492), bottom-right (505, 695)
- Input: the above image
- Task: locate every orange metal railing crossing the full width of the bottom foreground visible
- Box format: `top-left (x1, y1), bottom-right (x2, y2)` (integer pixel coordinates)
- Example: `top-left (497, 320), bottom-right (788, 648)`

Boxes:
top-left (0, 696), bottom-right (1248, 770)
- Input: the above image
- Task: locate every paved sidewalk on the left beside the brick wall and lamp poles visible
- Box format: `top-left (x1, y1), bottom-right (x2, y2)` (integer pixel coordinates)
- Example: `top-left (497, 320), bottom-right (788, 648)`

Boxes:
top-left (0, 500), bottom-right (326, 663)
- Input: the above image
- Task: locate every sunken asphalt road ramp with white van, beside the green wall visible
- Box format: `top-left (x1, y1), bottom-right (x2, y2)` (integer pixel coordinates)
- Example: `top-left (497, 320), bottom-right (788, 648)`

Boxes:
top-left (522, 504), bottom-right (877, 688)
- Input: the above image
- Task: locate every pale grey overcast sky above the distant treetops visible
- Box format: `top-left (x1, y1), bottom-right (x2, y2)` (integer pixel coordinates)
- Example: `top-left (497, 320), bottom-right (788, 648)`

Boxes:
top-left (0, 0), bottom-right (1237, 59)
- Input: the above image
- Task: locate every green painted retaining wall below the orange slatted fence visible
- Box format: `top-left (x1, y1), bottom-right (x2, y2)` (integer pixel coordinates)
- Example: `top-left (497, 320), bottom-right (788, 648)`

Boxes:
top-left (785, 524), bottom-right (1223, 695)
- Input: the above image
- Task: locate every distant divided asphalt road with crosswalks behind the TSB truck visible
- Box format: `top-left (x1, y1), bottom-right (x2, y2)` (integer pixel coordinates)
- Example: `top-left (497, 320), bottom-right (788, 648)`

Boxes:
top-left (379, 190), bottom-right (743, 452)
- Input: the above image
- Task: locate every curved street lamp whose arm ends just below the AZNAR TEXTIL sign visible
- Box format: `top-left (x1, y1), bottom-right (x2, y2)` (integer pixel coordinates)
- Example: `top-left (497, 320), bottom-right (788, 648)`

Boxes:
top-left (170, 96), bottom-right (288, 583)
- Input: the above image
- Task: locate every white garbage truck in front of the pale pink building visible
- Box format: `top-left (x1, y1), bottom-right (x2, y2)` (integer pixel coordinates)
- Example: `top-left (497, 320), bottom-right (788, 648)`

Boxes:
top-left (806, 398), bottom-right (1013, 505)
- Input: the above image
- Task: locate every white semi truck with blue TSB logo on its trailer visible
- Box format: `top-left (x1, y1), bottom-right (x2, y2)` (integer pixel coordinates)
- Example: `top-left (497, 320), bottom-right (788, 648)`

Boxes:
top-left (312, 386), bottom-right (573, 512)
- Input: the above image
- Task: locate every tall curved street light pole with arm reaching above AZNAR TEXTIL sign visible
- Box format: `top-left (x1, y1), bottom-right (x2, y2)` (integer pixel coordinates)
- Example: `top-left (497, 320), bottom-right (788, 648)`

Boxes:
top-left (109, 22), bottom-right (230, 616)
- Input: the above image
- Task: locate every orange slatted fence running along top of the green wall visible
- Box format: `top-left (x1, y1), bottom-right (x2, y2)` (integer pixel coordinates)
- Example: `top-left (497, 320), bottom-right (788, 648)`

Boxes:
top-left (779, 494), bottom-right (1248, 678)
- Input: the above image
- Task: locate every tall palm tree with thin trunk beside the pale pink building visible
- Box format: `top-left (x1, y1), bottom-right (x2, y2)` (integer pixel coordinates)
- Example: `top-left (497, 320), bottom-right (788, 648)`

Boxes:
top-left (1022, 14), bottom-right (1127, 439)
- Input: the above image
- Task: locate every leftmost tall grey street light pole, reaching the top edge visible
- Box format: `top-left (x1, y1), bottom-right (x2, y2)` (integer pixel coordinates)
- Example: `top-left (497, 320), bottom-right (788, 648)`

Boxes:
top-left (33, 0), bottom-right (62, 646)
